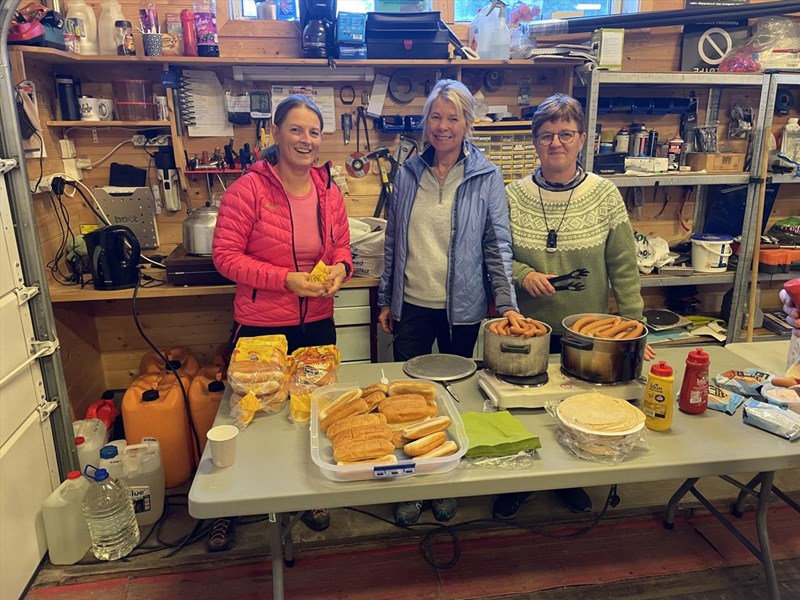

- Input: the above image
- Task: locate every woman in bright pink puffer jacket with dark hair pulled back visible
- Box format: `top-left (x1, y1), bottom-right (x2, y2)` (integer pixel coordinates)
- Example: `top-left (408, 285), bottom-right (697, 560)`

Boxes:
top-left (209, 95), bottom-right (353, 550)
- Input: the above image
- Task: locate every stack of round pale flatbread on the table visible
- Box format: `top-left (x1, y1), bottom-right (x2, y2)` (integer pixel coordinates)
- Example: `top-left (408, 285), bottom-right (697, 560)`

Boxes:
top-left (557, 392), bottom-right (644, 435)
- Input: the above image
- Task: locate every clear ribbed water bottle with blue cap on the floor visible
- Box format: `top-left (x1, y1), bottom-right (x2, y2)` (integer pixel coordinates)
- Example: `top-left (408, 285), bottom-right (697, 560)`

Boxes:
top-left (83, 465), bottom-right (139, 560)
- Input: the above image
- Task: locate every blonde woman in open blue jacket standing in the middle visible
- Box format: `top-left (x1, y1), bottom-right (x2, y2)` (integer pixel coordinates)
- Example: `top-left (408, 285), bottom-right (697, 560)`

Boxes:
top-left (378, 79), bottom-right (521, 525)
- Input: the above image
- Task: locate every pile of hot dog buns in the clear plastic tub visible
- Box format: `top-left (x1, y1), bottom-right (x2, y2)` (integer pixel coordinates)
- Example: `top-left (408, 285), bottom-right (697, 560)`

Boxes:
top-left (318, 380), bottom-right (458, 466)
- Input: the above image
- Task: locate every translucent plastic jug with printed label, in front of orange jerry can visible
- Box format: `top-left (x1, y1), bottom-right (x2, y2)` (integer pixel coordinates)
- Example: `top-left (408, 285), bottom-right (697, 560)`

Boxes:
top-left (122, 438), bottom-right (164, 526)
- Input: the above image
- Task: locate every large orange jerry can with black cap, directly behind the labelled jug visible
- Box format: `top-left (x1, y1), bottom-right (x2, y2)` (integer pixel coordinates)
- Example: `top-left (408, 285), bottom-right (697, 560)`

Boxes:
top-left (122, 373), bottom-right (196, 488)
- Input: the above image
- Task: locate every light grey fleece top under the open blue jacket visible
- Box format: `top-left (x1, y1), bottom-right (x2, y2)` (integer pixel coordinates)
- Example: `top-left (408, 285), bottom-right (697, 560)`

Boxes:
top-left (404, 160), bottom-right (464, 309)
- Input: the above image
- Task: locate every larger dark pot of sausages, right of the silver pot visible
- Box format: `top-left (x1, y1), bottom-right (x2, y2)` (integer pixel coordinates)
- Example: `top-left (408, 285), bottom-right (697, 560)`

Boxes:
top-left (561, 313), bottom-right (649, 384)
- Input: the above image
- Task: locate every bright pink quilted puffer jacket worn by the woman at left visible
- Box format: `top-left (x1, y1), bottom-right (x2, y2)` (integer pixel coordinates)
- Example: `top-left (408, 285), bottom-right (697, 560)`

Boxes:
top-left (212, 160), bottom-right (353, 327)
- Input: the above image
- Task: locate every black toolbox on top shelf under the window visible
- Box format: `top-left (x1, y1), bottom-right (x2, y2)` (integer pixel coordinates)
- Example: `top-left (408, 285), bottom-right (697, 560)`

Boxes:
top-left (366, 11), bottom-right (450, 60)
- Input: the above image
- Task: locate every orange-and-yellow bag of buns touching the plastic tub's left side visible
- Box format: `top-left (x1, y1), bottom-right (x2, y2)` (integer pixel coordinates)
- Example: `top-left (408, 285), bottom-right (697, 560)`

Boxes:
top-left (289, 345), bottom-right (341, 423)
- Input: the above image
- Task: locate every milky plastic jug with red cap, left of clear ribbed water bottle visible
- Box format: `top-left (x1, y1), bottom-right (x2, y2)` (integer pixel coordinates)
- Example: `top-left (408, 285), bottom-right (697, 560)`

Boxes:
top-left (42, 471), bottom-right (92, 565)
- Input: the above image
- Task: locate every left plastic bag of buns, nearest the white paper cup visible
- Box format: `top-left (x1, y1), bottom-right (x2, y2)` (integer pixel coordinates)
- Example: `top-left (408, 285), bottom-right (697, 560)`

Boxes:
top-left (228, 335), bottom-right (288, 428)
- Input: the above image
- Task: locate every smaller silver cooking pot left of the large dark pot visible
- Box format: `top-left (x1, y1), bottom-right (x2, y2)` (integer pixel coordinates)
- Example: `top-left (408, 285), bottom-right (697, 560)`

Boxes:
top-left (483, 317), bottom-right (553, 377)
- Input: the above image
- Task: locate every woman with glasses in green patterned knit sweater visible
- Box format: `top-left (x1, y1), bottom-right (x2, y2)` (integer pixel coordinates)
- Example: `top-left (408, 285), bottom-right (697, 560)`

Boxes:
top-left (493, 94), bottom-right (652, 519)
